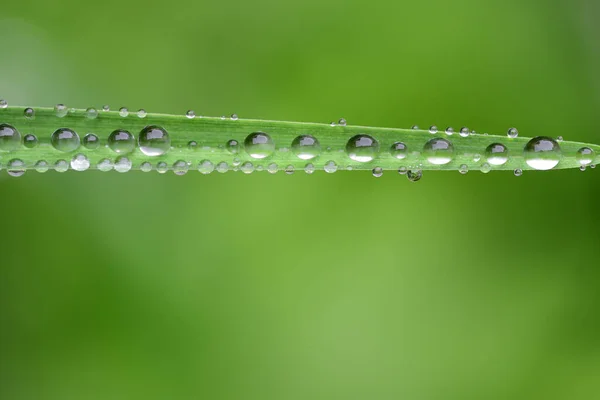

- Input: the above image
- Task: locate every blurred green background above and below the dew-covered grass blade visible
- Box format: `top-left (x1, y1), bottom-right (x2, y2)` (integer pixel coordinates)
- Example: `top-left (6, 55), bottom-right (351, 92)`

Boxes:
top-left (0, 0), bottom-right (600, 400)
